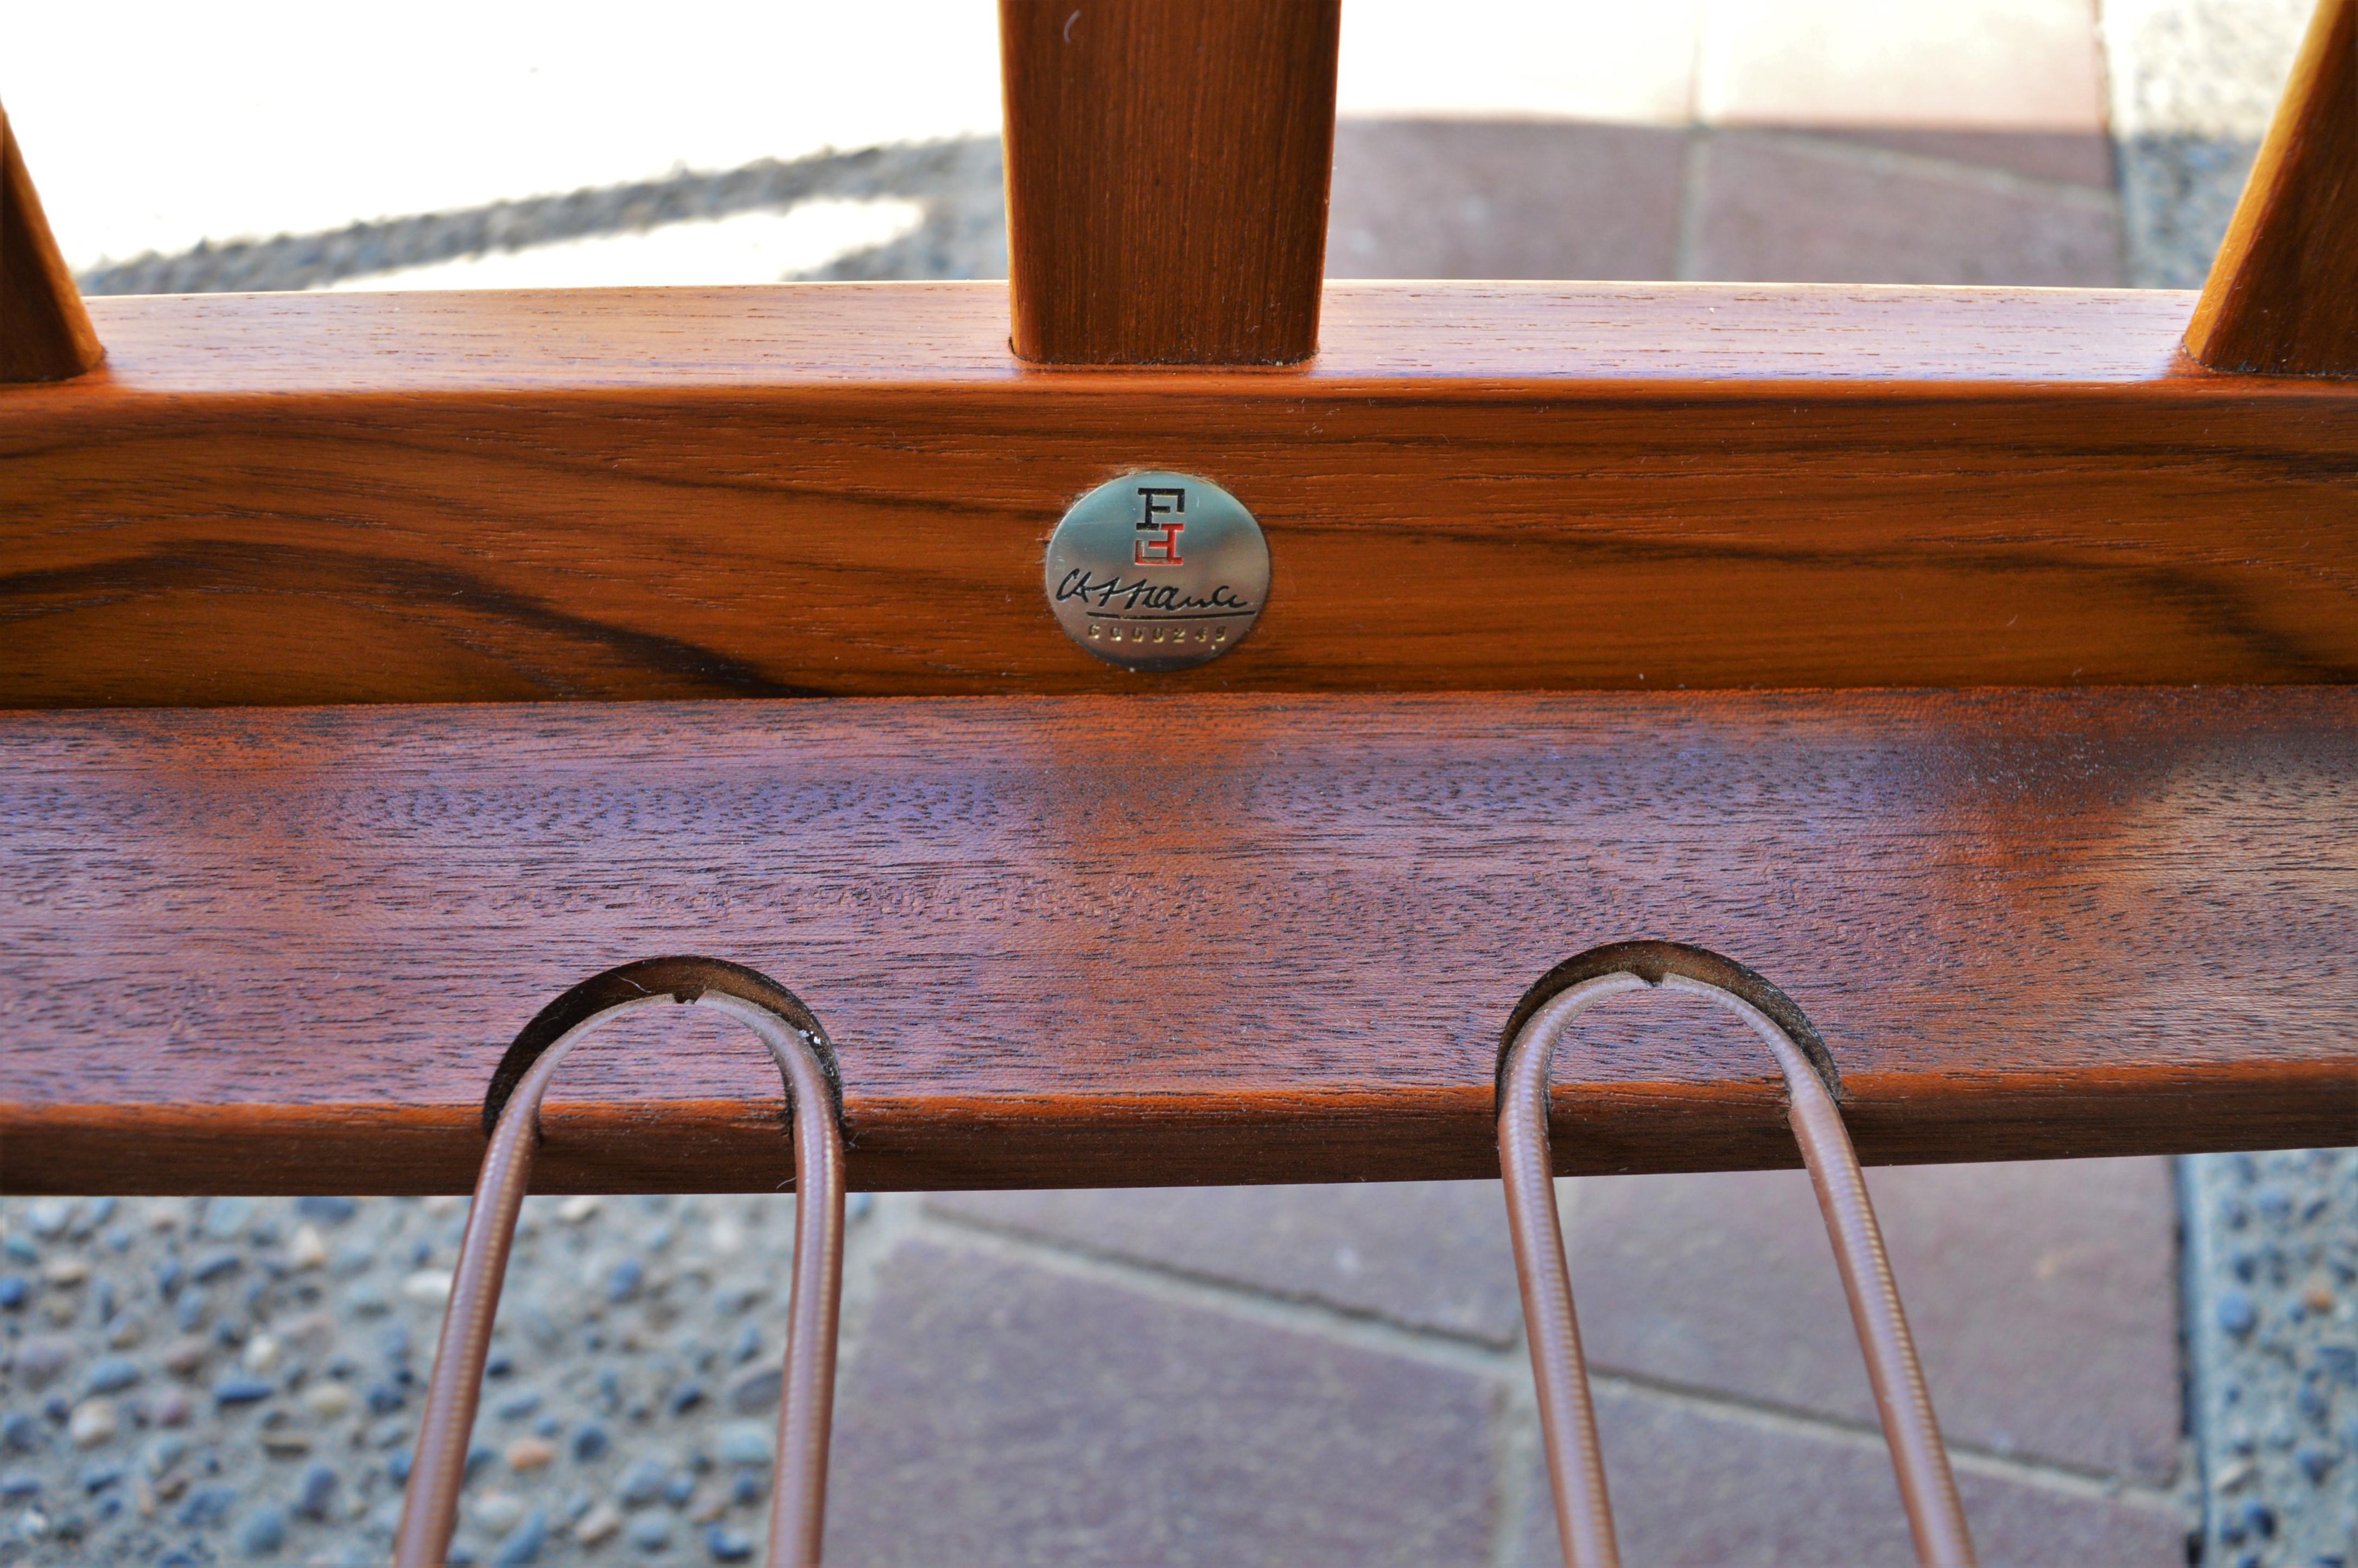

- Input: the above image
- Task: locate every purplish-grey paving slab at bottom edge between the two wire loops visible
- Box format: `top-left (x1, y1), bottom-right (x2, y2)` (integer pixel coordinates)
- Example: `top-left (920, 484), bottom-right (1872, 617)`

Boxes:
top-left (828, 1240), bottom-right (1495, 1568)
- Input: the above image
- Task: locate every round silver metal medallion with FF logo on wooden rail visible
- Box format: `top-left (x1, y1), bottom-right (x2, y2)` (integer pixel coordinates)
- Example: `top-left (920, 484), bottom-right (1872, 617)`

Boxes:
top-left (1047, 472), bottom-right (1269, 670)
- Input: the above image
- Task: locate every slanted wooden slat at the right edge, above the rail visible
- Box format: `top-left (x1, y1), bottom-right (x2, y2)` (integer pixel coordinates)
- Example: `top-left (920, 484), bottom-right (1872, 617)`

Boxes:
top-left (2186, 0), bottom-right (2358, 375)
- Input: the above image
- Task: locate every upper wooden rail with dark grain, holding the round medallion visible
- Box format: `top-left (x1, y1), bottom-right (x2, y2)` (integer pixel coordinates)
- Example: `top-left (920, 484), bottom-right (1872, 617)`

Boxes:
top-left (0, 285), bottom-right (2358, 707)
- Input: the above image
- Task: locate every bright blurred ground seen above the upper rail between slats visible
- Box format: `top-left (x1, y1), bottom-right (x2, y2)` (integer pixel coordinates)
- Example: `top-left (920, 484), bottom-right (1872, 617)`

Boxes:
top-left (0, 0), bottom-right (2306, 293)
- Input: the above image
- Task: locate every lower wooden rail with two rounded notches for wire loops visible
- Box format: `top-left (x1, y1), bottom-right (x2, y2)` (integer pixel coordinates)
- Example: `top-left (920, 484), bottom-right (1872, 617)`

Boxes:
top-left (0, 689), bottom-right (2358, 1193)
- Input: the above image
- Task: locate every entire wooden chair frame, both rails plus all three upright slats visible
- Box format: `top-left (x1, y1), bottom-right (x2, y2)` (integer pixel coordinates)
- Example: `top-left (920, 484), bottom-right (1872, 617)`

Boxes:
top-left (0, 0), bottom-right (2358, 1191)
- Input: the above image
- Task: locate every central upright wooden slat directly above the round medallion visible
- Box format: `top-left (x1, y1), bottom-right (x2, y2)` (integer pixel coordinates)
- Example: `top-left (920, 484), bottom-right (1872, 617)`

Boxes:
top-left (1000, 0), bottom-right (1342, 365)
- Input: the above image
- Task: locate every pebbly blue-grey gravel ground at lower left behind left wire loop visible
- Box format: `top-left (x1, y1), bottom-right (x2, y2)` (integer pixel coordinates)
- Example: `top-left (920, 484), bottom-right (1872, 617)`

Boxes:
top-left (0, 1198), bottom-right (830, 1568)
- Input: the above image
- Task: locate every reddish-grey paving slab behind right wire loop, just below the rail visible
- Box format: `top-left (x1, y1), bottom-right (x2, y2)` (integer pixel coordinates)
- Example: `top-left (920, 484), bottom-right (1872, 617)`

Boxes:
top-left (1566, 1160), bottom-right (2181, 1488)
